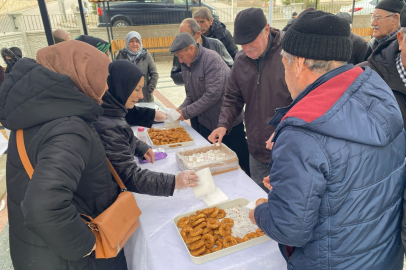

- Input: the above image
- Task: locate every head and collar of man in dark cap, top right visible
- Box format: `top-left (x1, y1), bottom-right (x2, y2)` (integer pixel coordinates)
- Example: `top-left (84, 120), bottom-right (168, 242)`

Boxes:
top-left (365, 0), bottom-right (405, 60)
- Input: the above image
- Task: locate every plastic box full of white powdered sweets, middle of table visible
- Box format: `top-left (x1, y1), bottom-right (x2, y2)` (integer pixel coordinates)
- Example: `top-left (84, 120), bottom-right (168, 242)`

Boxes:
top-left (176, 143), bottom-right (239, 175)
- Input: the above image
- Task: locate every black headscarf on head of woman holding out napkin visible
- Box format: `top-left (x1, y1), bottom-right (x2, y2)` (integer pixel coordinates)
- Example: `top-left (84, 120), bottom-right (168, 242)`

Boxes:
top-left (107, 60), bottom-right (144, 106)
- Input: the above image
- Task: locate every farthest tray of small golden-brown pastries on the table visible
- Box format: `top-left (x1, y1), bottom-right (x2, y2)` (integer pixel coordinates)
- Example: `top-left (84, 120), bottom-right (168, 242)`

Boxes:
top-left (147, 125), bottom-right (194, 149)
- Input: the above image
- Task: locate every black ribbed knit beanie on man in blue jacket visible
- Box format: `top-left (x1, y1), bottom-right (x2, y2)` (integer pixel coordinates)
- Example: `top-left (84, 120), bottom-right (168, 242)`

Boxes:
top-left (282, 10), bottom-right (352, 61)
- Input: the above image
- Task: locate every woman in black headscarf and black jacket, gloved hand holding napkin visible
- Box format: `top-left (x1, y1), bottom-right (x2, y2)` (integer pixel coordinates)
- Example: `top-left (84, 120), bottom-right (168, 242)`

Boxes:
top-left (95, 60), bottom-right (197, 196)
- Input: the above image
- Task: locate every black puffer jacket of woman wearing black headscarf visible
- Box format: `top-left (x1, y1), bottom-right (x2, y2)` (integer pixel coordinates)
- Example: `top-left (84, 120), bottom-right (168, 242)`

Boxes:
top-left (94, 91), bottom-right (175, 196)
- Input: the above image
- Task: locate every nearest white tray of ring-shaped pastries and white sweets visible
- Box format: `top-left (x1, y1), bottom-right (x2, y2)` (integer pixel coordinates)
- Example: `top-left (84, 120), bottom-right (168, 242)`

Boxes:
top-left (173, 198), bottom-right (271, 264)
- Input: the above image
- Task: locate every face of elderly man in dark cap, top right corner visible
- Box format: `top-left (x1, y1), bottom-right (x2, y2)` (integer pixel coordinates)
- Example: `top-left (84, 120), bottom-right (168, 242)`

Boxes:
top-left (371, 8), bottom-right (399, 40)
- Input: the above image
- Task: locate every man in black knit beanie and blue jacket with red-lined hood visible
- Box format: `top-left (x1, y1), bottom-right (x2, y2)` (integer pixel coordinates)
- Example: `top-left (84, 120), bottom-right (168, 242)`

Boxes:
top-left (249, 10), bottom-right (406, 270)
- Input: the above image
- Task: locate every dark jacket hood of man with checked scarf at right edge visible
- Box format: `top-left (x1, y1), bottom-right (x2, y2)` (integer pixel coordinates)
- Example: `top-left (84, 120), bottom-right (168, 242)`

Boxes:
top-left (368, 35), bottom-right (406, 94)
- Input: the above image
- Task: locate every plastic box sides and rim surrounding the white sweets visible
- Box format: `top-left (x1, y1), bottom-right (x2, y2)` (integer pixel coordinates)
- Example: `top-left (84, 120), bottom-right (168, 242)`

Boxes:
top-left (176, 143), bottom-right (239, 175)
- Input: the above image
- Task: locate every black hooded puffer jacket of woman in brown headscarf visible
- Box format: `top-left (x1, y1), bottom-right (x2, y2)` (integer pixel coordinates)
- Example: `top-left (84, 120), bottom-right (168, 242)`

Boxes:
top-left (0, 58), bottom-right (127, 270)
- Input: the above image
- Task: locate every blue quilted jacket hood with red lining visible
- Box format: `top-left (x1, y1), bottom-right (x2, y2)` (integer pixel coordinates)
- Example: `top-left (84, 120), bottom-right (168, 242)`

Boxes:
top-left (275, 67), bottom-right (403, 146)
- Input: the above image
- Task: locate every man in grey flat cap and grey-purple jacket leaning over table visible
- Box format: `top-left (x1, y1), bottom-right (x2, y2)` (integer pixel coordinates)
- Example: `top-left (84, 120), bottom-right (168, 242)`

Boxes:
top-left (169, 32), bottom-right (250, 175)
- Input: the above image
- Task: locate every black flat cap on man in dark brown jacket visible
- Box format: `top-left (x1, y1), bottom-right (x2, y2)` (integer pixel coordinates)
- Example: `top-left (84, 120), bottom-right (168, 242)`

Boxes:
top-left (234, 8), bottom-right (267, 45)
